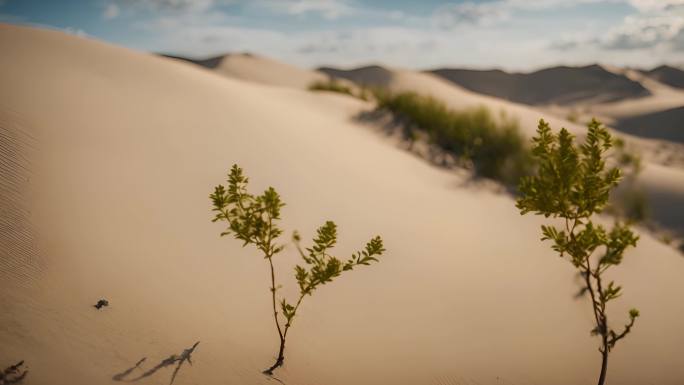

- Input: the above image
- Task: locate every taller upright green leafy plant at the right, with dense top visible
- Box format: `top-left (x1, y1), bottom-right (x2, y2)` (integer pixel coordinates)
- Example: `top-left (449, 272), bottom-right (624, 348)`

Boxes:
top-left (517, 120), bottom-right (639, 385)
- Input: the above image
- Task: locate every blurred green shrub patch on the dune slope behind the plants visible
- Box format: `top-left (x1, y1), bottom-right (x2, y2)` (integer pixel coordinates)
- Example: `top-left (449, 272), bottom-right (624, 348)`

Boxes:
top-left (375, 90), bottom-right (532, 185)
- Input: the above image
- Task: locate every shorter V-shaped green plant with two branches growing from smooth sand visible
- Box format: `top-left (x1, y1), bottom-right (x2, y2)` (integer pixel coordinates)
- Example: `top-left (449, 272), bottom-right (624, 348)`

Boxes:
top-left (210, 165), bottom-right (385, 375)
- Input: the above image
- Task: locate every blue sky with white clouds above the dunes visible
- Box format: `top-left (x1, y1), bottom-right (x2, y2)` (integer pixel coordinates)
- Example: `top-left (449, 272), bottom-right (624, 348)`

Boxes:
top-left (0, 0), bottom-right (684, 71)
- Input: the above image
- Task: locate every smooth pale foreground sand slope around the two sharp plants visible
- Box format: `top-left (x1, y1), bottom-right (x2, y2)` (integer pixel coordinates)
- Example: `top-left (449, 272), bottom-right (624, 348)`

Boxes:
top-left (0, 25), bottom-right (684, 385)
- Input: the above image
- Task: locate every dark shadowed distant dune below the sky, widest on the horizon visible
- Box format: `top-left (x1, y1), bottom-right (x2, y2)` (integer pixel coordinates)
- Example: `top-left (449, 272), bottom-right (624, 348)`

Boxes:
top-left (429, 65), bottom-right (649, 105)
